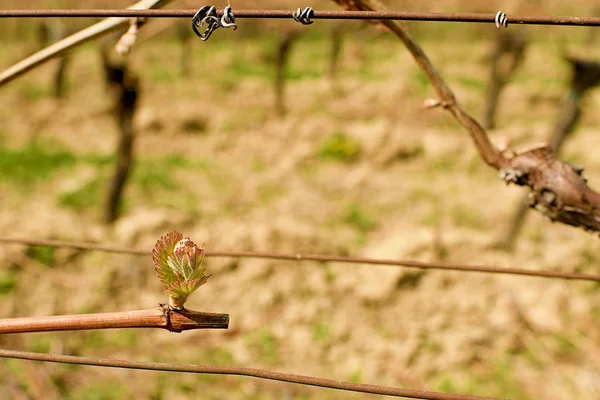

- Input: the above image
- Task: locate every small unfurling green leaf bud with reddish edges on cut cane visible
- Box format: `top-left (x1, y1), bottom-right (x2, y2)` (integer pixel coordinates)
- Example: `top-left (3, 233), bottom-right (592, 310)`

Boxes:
top-left (152, 232), bottom-right (210, 309)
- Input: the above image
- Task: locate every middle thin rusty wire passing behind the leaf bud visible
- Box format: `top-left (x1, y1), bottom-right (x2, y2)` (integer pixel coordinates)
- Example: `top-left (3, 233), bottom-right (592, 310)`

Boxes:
top-left (0, 237), bottom-right (600, 282)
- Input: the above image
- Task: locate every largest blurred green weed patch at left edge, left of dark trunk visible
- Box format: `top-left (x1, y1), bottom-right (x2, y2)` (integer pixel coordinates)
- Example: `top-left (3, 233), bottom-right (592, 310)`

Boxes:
top-left (0, 143), bottom-right (77, 186)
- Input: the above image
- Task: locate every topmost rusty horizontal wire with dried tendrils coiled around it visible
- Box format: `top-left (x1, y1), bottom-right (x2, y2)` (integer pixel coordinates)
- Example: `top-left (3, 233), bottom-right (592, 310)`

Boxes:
top-left (0, 9), bottom-right (600, 26)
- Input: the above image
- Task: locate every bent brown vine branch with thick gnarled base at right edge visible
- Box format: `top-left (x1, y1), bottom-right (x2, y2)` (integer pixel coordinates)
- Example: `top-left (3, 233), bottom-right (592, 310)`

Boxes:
top-left (335, 0), bottom-right (600, 232)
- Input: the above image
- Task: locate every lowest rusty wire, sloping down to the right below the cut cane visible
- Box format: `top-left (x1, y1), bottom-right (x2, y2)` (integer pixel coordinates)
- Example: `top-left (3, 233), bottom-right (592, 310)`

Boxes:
top-left (0, 349), bottom-right (501, 400)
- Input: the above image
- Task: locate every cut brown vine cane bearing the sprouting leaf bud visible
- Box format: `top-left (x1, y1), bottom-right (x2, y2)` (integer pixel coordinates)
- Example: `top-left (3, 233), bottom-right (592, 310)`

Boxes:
top-left (0, 306), bottom-right (229, 334)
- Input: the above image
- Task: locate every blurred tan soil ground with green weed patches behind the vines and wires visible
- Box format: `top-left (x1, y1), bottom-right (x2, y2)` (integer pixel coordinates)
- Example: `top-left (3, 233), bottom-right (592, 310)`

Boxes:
top-left (0, 0), bottom-right (600, 400)
